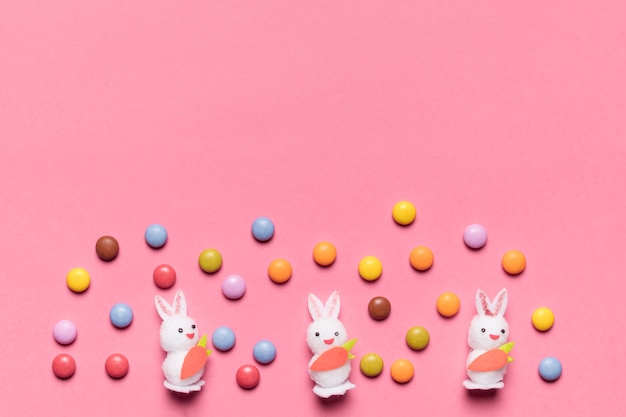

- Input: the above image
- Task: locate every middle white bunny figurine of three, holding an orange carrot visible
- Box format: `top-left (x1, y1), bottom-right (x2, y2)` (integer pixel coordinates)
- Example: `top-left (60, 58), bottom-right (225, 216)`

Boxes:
top-left (306, 291), bottom-right (356, 398)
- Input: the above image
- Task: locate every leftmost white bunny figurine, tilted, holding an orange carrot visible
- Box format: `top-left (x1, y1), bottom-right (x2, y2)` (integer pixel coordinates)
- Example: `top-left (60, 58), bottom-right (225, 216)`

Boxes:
top-left (154, 290), bottom-right (211, 394)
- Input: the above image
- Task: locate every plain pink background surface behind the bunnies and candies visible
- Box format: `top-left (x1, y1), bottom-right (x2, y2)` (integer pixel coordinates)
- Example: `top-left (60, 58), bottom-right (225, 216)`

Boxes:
top-left (0, 0), bottom-right (626, 417)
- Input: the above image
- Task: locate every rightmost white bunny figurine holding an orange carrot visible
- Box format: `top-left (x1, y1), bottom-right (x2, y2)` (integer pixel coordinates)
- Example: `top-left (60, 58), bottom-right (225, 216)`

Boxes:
top-left (463, 288), bottom-right (513, 390)
